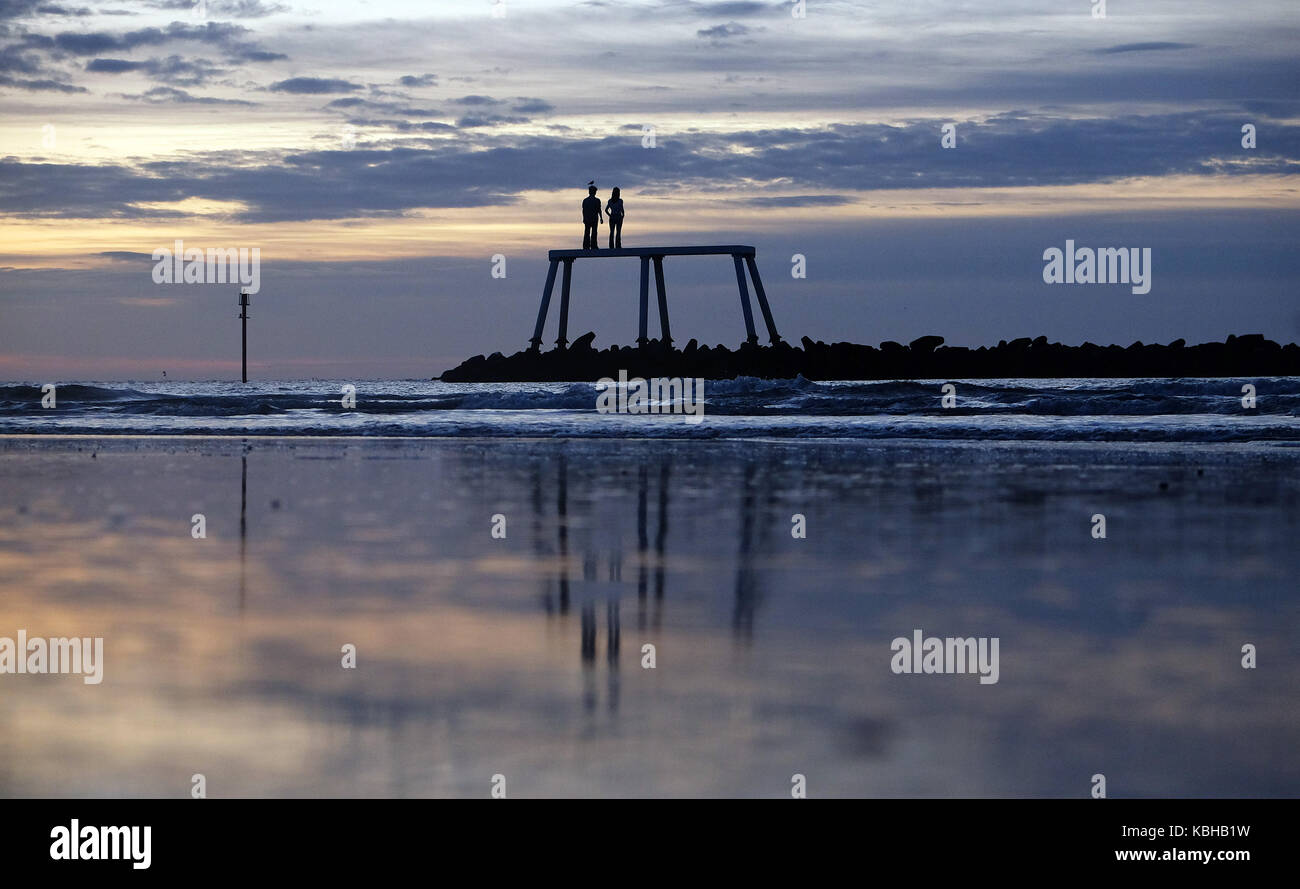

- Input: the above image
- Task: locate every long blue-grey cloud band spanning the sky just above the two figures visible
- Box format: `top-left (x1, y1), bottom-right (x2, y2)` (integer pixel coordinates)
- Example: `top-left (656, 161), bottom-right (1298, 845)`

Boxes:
top-left (0, 109), bottom-right (1300, 222)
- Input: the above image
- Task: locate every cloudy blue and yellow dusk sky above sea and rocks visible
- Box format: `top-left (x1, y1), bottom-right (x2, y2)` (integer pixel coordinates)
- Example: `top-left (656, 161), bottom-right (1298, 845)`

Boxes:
top-left (0, 0), bottom-right (1300, 382)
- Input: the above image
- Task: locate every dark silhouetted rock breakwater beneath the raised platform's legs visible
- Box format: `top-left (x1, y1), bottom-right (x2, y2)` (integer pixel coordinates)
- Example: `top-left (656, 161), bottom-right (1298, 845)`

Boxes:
top-left (434, 333), bottom-right (1300, 382)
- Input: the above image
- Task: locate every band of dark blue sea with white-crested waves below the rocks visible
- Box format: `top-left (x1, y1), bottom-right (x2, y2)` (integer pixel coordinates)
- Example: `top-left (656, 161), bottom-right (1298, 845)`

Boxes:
top-left (0, 377), bottom-right (1300, 442)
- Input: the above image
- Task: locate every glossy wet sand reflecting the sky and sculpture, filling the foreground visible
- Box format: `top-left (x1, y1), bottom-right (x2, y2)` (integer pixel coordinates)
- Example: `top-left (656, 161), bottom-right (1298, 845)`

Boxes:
top-left (0, 439), bottom-right (1300, 797)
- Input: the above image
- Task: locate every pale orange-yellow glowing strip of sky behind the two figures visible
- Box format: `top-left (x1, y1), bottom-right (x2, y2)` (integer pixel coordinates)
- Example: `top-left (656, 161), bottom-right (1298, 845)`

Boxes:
top-left (0, 175), bottom-right (1300, 269)
